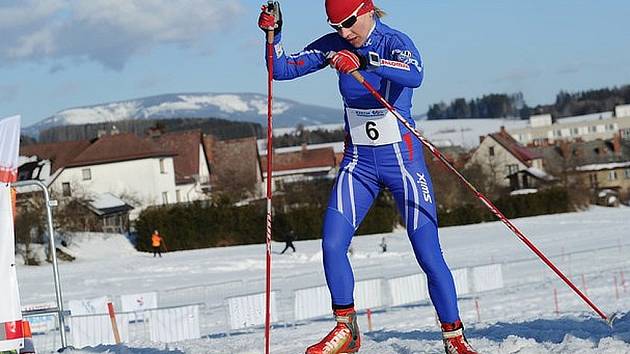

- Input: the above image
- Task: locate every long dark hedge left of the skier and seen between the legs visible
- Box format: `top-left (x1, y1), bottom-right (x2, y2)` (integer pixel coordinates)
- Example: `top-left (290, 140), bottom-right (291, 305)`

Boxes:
top-left (136, 193), bottom-right (398, 252)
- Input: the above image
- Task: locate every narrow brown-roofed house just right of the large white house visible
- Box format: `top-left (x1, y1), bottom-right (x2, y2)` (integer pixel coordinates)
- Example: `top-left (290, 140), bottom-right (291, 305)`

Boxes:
top-left (146, 129), bottom-right (210, 203)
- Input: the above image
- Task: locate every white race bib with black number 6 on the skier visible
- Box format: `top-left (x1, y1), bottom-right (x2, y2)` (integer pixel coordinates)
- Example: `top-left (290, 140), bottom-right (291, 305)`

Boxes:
top-left (346, 108), bottom-right (401, 146)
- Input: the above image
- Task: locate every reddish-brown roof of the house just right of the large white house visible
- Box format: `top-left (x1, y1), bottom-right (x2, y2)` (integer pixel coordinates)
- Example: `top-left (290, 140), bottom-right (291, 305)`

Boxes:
top-left (145, 129), bottom-right (202, 184)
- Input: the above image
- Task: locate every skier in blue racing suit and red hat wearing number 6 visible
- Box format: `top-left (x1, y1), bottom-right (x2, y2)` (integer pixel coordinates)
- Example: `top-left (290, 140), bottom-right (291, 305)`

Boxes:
top-left (258, 0), bottom-right (476, 354)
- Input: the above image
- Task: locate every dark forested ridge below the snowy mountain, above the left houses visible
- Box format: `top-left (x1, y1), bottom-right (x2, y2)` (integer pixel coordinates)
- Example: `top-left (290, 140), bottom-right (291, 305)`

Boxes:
top-left (38, 118), bottom-right (262, 143)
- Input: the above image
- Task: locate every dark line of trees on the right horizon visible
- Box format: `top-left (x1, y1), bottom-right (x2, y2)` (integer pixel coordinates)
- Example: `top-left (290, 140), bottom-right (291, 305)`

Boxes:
top-left (427, 85), bottom-right (630, 119)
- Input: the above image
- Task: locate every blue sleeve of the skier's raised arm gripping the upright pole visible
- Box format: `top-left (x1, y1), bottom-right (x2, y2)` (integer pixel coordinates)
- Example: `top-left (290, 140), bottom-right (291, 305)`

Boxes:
top-left (265, 33), bottom-right (330, 80)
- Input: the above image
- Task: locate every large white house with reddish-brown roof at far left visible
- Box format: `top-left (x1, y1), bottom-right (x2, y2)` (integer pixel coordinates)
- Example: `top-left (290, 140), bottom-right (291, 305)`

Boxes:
top-left (18, 134), bottom-right (177, 220)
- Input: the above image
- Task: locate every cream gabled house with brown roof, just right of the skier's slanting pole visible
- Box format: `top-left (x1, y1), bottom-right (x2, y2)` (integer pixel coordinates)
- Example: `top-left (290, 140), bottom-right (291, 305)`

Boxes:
top-left (466, 127), bottom-right (552, 190)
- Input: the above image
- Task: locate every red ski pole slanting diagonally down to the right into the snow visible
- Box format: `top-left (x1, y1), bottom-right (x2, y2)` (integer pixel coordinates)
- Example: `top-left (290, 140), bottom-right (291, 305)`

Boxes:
top-left (350, 70), bottom-right (615, 325)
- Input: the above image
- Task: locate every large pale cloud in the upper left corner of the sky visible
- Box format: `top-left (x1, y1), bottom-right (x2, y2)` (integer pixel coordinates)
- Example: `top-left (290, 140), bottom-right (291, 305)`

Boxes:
top-left (0, 0), bottom-right (243, 70)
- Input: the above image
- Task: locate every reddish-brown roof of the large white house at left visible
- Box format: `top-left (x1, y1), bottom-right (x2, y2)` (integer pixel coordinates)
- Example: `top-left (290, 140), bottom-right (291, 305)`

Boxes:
top-left (67, 133), bottom-right (175, 167)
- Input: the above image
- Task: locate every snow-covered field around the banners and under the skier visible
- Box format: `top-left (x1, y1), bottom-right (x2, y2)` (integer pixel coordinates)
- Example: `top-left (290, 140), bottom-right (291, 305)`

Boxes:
top-left (18, 207), bottom-right (630, 354)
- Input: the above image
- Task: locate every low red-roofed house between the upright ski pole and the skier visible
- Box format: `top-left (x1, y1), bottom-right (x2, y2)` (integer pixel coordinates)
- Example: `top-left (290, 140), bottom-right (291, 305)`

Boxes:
top-left (261, 145), bottom-right (339, 190)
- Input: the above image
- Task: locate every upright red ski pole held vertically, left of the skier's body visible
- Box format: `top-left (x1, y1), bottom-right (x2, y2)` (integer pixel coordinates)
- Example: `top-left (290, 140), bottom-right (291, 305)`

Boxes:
top-left (265, 1), bottom-right (275, 354)
